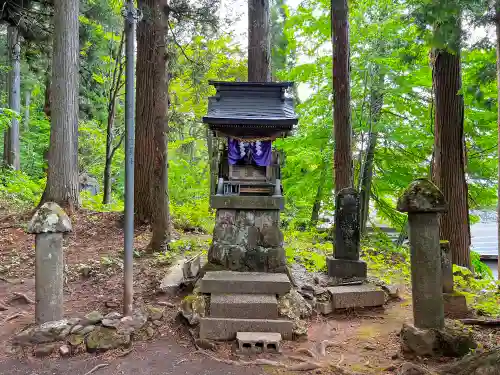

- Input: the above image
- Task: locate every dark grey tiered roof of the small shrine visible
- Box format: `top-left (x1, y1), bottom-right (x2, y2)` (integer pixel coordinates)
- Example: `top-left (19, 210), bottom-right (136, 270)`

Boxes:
top-left (203, 81), bottom-right (298, 130)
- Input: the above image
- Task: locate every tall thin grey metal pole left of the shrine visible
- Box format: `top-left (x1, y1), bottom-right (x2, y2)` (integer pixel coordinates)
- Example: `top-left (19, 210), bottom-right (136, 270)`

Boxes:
top-left (123, 0), bottom-right (137, 316)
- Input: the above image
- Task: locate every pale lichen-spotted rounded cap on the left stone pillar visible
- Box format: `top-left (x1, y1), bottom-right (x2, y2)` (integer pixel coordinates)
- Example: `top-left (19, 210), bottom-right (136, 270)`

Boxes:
top-left (28, 202), bottom-right (73, 234)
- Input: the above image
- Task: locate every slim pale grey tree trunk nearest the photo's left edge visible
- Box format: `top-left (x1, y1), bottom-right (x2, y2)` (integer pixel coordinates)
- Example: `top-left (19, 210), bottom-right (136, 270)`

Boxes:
top-left (6, 26), bottom-right (21, 171)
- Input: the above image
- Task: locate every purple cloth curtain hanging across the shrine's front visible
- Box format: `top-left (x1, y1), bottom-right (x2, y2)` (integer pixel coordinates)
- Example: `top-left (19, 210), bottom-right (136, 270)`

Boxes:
top-left (228, 138), bottom-right (272, 167)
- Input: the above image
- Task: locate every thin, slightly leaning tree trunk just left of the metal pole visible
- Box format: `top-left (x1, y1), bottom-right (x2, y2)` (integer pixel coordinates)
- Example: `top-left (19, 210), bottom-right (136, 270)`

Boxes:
top-left (102, 34), bottom-right (125, 204)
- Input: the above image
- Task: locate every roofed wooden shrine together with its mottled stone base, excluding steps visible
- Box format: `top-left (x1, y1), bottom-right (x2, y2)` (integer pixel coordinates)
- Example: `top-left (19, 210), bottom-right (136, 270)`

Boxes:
top-left (203, 82), bottom-right (298, 272)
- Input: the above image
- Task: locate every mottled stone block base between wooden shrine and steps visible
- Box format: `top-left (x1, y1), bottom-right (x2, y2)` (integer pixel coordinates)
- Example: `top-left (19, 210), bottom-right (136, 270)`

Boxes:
top-left (208, 209), bottom-right (286, 272)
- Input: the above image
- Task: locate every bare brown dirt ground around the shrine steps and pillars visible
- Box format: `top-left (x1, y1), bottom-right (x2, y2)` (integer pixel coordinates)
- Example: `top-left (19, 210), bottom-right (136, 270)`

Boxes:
top-left (0, 211), bottom-right (500, 375)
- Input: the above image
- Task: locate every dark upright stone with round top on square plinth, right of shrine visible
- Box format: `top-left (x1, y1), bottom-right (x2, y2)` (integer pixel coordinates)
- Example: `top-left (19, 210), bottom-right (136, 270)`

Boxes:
top-left (327, 188), bottom-right (366, 279)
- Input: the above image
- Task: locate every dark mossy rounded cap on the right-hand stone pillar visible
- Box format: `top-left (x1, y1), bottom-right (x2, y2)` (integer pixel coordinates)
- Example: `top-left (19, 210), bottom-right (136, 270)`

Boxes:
top-left (397, 178), bottom-right (448, 213)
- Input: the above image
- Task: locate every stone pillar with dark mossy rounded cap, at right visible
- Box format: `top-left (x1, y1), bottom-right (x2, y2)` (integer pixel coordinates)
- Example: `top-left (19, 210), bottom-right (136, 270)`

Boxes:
top-left (397, 179), bottom-right (446, 329)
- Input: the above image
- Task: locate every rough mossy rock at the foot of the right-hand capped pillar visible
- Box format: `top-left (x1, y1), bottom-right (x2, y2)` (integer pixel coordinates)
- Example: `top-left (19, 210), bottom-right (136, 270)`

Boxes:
top-left (401, 324), bottom-right (477, 357)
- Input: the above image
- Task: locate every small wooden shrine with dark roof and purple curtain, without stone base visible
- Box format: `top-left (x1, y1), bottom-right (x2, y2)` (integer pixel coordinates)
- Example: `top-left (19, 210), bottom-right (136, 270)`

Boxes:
top-left (203, 82), bottom-right (298, 209)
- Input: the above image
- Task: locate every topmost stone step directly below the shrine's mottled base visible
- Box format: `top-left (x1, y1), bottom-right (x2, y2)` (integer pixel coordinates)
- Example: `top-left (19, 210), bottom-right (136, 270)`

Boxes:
top-left (200, 271), bottom-right (291, 295)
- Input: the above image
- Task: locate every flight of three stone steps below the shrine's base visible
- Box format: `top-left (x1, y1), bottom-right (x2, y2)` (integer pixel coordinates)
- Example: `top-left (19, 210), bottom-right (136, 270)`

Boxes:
top-left (200, 271), bottom-right (293, 340)
